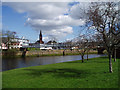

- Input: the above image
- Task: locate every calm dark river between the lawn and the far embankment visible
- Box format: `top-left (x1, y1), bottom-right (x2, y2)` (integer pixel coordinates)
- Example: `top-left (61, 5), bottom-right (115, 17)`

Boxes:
top-left (2, 54), bottom-right (105, 71)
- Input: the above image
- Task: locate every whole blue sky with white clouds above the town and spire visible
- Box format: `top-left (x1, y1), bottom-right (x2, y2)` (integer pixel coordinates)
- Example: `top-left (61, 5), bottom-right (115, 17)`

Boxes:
top-left (2, 2), bottom-right (88, 42)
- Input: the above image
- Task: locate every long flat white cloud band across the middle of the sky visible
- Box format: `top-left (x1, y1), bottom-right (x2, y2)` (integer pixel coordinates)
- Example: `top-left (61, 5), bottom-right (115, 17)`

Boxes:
top-left (26, 15), bottom-right (85, 30)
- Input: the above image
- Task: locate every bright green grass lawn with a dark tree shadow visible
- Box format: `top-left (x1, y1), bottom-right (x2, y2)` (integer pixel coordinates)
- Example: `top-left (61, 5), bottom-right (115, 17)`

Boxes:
top-left (2, 57), bottom-right (118, 88)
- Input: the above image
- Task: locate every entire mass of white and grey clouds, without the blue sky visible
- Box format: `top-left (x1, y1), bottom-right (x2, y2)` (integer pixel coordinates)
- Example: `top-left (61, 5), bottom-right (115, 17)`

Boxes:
top-left (4, 2), bottom-right (85, 40)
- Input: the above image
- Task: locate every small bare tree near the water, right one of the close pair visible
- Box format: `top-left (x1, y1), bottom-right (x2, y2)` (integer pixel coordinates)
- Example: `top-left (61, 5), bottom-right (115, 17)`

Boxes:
top-left (79, 23), bottom-right (95, 61)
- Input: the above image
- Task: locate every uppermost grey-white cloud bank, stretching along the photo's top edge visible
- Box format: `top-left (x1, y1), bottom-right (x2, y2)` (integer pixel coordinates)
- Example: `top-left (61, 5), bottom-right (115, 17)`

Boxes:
top-left (4, 2), bottom-right (68, 19)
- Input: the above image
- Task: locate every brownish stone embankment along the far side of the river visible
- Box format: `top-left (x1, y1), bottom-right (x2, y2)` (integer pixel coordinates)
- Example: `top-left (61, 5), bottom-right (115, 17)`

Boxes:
top-left (2, 50), bottom-right (97, 58)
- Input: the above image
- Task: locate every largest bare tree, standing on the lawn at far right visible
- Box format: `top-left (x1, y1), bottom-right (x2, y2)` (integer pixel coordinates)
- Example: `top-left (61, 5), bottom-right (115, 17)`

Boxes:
top-left (87, 2), bottom-right (120, 73)
